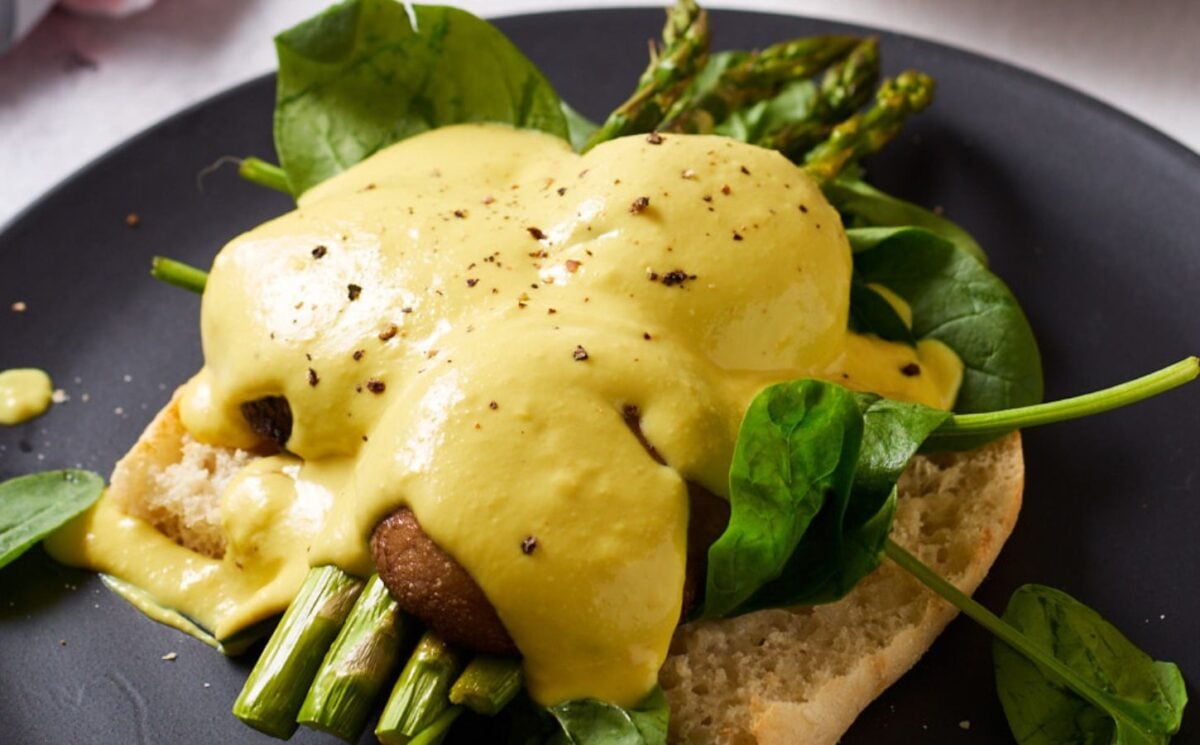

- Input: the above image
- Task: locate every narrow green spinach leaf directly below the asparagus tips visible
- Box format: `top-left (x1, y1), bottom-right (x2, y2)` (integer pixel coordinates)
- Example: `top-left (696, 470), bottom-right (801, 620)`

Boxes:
top-left (822, 173), bottom-right (988, 266)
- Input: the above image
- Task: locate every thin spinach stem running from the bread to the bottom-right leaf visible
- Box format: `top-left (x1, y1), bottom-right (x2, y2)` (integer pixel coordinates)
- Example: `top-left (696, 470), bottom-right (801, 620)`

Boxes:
top-left (883, 539), bottom-right (1152, 722)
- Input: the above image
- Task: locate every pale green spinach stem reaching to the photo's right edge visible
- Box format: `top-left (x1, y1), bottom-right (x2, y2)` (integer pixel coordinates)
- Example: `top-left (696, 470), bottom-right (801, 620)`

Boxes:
top-left (936, 356), bottom-right (1200, 438)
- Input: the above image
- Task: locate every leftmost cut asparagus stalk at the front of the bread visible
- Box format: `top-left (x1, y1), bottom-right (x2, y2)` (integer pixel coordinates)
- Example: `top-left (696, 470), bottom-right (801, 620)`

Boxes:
top-left (233, 566), bottom-right (362, 739)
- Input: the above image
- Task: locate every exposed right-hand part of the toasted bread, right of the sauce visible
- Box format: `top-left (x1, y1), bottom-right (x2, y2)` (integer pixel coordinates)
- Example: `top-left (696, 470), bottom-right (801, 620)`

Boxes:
top-left (660, 434), bottom-right (1025, 745)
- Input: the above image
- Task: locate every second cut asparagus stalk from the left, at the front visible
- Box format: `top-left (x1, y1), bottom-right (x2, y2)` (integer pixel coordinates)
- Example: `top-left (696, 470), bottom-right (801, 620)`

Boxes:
top-left (296, 575), bottom-right (404, 743)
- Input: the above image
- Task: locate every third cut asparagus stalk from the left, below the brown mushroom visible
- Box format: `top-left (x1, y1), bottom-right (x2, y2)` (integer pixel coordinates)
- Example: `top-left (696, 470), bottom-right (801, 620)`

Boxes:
top-left (376, 631), bottom-right (462, 745)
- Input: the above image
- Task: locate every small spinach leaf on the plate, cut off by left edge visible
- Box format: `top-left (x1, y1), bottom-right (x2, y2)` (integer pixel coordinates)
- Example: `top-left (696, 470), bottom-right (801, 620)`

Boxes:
top-left (0, 469), bottom-right (104, 567)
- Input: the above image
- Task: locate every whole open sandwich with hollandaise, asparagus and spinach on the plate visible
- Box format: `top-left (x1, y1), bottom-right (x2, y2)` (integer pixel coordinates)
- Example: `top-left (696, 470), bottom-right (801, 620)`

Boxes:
top-left (7, 0), bottom-right (1196, 743)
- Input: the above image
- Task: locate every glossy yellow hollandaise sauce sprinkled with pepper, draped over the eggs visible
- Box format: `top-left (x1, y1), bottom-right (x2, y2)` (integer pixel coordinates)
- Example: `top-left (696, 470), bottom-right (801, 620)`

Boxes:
top-left (51, 125), bottom-right (962, 705)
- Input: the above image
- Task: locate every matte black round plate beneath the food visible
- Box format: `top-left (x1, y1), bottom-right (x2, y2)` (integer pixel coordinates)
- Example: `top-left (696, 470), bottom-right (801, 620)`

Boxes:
top-left (0, 10), bottom-right (1200, 744)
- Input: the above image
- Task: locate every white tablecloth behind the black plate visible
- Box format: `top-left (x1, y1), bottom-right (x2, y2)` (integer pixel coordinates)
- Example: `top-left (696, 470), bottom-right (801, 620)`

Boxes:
top-left (0, 0), bottom-right (1200, 226)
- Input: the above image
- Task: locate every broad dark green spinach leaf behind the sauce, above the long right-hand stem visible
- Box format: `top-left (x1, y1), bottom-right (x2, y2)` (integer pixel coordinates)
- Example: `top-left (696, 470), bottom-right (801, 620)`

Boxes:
top-left (846, 228), bottom-right (1042, 415)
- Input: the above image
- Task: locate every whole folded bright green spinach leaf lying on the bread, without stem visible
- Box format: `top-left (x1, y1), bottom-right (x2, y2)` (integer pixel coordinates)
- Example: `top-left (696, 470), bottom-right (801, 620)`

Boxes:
top-left (704, 380), bottom-right (950, 617)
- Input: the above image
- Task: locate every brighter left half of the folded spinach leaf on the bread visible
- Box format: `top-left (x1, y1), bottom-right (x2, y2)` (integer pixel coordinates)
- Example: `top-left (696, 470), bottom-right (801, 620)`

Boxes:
top-left (703, 380), bottom-right (863, 618)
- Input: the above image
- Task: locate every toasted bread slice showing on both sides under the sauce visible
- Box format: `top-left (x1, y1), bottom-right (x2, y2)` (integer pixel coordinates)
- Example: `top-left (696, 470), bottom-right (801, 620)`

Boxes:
top-left (109, 395), bottom-right (1025, 745)
